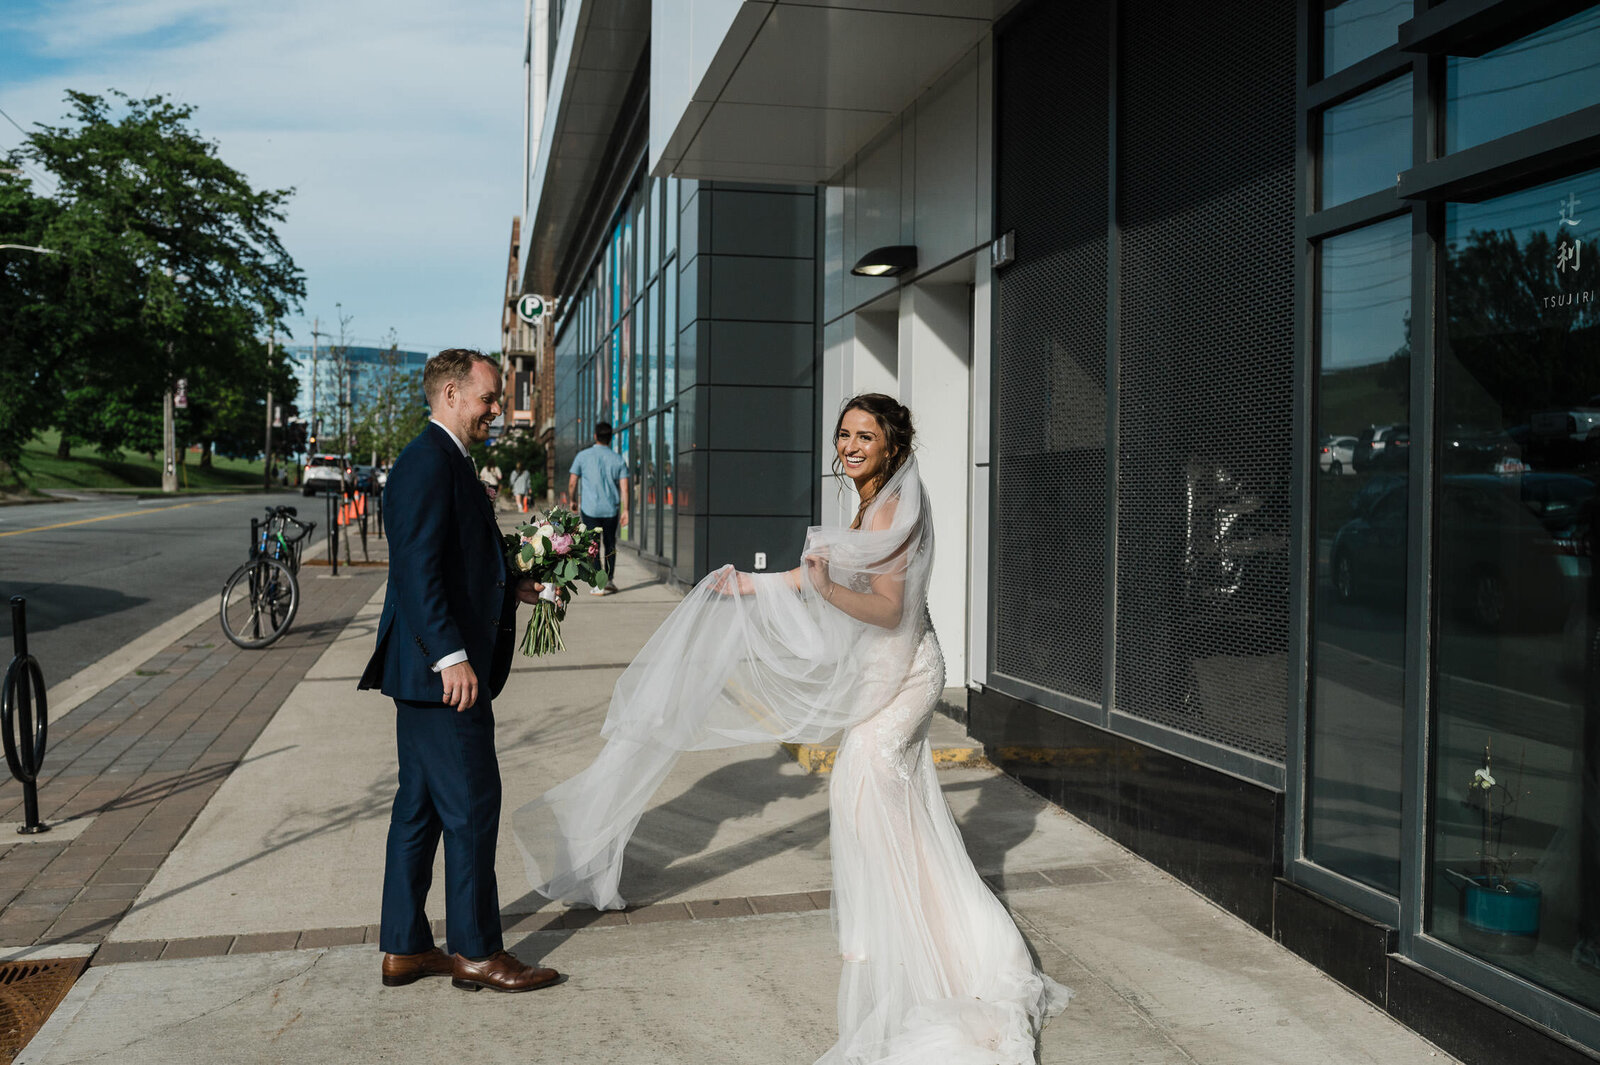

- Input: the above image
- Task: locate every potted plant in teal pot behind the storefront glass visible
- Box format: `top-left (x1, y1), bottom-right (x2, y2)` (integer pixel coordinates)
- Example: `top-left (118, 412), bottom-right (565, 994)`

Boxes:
top-left (1451, 740), bottom-right (1542, 955)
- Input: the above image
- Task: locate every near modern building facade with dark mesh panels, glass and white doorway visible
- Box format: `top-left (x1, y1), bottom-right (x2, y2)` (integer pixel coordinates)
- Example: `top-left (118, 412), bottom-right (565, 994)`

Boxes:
top-left (523, 0), bottom-right (1600, 1062)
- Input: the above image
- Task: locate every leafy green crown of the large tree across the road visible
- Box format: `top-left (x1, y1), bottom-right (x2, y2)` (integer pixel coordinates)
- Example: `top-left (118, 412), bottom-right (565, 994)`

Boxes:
top-left (0, 93), bottom-right (304, 476)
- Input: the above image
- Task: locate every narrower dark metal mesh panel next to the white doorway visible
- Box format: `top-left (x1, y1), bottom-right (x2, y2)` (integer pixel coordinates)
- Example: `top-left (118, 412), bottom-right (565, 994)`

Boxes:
top-left (994, 3), bottom-right (1109, 702)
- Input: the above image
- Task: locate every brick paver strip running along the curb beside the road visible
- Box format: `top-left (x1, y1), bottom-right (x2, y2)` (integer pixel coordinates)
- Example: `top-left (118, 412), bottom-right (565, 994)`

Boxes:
top-left (0, 556), bottom-right (386, 946)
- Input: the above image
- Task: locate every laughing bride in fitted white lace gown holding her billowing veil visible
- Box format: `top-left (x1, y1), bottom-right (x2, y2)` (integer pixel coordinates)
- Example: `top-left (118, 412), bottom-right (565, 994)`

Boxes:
top-left (512, 393), bottom-right (1072, 1065)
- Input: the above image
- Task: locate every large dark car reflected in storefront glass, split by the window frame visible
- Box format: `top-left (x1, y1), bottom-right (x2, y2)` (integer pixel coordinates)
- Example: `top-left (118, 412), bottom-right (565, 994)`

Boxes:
top-left (1330, 473), bottom-right (1595, 632)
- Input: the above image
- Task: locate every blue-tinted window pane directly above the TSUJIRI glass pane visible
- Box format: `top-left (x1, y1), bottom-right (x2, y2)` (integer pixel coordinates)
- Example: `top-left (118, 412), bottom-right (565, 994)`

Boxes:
top-left (1445, 6), bottom-right (1600, 154)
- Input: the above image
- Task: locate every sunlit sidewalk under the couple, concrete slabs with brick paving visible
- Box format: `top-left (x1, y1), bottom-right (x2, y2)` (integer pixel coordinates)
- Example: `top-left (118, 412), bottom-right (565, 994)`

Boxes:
top-left (0, 540), bottom-right (1448, 1065)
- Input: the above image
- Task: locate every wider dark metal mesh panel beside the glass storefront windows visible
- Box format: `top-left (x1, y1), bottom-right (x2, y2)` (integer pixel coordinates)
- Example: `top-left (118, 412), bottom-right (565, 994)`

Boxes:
top-left (1117, 0), bottom-right (1296, 761)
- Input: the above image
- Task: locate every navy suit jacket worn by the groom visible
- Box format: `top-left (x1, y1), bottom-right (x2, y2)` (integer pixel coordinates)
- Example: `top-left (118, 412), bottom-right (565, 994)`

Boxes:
top-left (360, 422), bottom-right (517, 702)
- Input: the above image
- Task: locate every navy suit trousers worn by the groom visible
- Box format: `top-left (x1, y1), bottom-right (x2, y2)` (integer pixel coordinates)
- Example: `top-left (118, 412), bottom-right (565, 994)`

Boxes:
top-left (378, 689), bottom-right (502, 958)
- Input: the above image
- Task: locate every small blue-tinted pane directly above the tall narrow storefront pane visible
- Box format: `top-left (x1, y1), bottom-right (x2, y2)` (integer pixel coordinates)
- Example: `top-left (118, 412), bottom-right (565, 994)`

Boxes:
top-left (1318, 74), bottom-right (1411, 208)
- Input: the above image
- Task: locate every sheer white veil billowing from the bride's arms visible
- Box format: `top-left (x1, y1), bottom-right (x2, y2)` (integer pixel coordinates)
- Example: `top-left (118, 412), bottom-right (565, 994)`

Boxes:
top-left (512, 457), bottom-right (933, 910)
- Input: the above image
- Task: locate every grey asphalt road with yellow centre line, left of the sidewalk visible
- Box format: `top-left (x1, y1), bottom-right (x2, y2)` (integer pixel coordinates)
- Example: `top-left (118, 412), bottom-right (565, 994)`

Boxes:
top-left (0, 493), bottom-right (323, 686)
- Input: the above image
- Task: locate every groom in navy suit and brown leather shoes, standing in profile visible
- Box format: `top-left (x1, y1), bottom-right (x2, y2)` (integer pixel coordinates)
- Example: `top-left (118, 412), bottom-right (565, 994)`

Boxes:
top-left (360, 349), bottom-right (560, 991)
